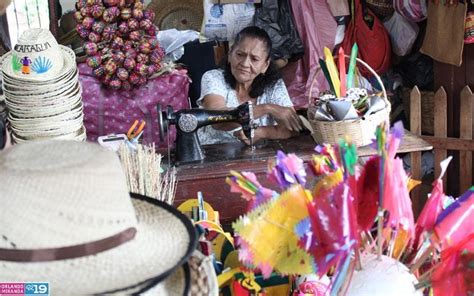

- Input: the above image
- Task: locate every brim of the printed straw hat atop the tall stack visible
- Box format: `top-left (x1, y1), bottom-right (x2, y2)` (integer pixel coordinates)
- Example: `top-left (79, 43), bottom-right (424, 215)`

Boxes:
top-left (0, 45), bottom-right (76, 82)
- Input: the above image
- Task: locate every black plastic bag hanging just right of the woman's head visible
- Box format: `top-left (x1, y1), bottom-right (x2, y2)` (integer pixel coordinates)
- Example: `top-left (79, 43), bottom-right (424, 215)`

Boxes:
top-left (254, 0), bottom-right (304, 61)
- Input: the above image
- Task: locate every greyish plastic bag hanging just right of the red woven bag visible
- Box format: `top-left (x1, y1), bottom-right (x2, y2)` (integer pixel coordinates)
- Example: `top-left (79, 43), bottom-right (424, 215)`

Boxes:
top-left (383, 12), bottom-right (419, 56)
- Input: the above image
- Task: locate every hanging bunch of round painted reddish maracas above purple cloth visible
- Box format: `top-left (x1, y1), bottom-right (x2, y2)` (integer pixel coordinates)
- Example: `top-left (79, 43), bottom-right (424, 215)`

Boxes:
top-left (74, 0), bottom-right (164, 90)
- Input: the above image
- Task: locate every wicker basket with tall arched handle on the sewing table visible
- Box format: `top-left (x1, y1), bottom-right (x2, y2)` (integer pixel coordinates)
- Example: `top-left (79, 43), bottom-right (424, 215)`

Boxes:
top-left (308, 56), bottom-right (391, 147)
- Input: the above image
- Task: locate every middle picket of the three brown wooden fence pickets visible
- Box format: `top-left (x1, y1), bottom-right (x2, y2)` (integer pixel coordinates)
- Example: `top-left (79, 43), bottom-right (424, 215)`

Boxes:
top-left (433, 87), bottom-right (448, 188)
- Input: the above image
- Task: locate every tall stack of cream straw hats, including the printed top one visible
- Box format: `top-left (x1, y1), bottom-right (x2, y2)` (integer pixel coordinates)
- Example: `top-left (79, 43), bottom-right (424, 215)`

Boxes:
top-left (1, 29), bottom-right (86, 143)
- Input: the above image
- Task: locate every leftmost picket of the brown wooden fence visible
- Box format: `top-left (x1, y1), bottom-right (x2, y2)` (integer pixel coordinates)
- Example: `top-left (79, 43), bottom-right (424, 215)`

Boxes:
top-left (410, 86), bottom-right (424, 216)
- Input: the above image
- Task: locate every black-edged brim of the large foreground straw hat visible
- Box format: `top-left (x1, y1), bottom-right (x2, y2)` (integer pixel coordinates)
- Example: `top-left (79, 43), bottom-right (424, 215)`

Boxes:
top-left (0, 194), bottom-right (197, 295)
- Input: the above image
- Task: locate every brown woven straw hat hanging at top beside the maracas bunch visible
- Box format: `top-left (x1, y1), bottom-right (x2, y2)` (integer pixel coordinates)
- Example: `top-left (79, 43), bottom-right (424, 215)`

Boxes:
top-left (147, 0), bottom-right (204, 31)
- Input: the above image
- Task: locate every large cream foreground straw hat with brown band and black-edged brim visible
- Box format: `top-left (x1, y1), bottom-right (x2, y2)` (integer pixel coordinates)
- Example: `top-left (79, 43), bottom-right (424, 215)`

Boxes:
top-left (0, 141), bottom-right (196, 295)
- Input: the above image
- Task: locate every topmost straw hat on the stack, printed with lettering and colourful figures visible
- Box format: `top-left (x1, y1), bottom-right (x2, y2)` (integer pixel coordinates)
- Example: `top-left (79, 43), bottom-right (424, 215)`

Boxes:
top-left (2, 28), bottom-right (75, 82)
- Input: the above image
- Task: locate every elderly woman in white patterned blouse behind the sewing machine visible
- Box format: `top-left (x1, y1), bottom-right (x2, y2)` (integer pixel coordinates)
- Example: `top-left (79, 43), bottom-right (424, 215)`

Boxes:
top-left (197, 27), bottom-right (302, 144)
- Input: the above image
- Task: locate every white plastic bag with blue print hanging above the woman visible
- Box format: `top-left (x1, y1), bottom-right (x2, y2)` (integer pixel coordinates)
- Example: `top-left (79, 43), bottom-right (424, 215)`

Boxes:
top-left (200, 0), bottom-right (255, 42)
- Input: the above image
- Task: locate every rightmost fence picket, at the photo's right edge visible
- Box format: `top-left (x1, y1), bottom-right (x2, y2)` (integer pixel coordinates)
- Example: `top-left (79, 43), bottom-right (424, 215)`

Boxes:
top-left (459, 85), bottom-right (474, 194)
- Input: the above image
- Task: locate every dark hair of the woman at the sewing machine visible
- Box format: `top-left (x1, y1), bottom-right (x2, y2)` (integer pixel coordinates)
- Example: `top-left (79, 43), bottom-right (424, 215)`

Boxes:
top-left (221, 26), bottom-right (281, 98)
